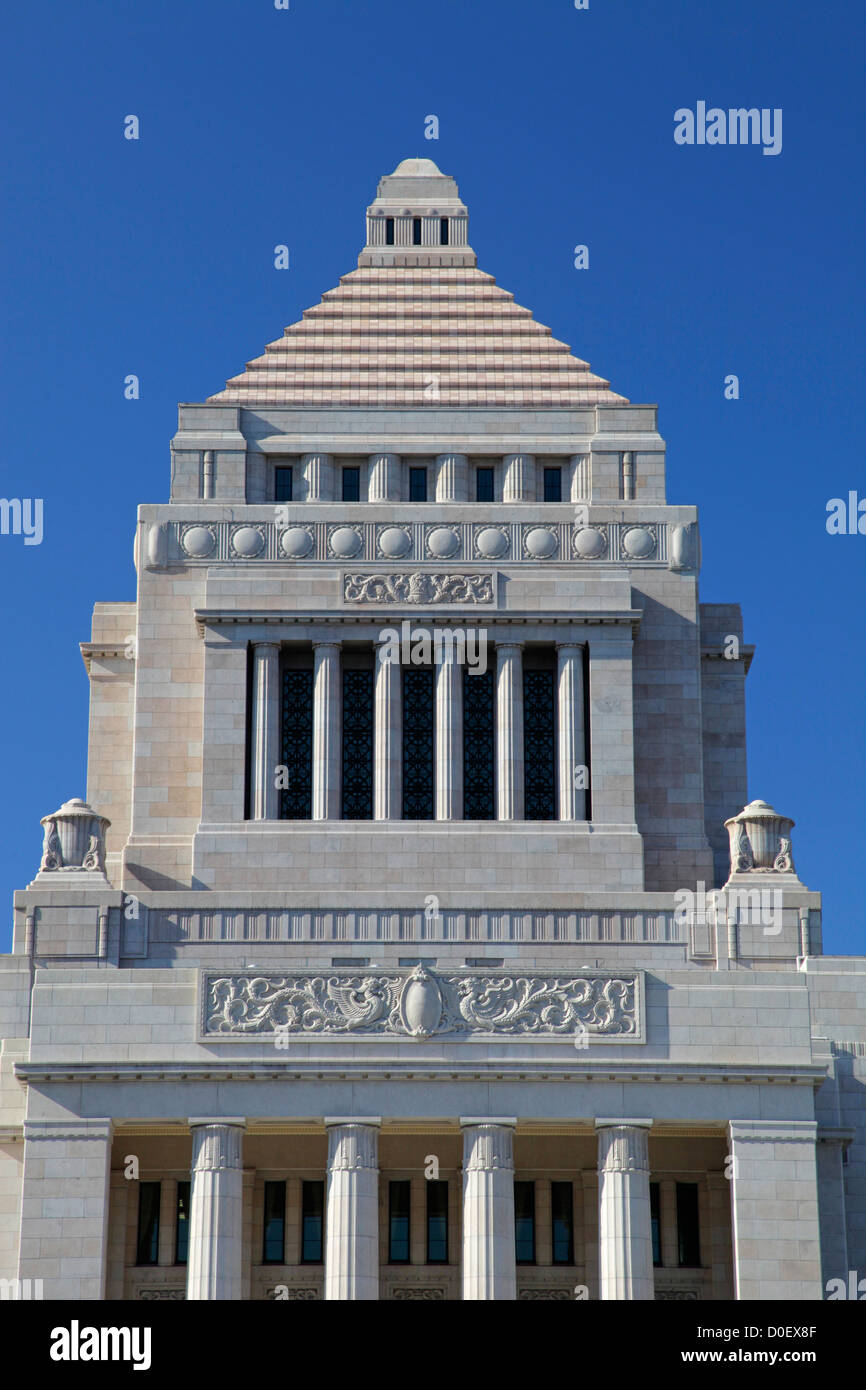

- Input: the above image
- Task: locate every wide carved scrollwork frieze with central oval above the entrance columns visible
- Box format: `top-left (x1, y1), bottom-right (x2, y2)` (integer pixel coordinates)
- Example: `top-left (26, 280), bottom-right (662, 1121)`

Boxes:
top-left (202, 966), bottom-right (644, 1047)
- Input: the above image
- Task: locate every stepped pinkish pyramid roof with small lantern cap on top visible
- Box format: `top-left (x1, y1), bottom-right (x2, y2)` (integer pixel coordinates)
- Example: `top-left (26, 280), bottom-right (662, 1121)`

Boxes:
top-left (210, 158), bottom-right (627, 409)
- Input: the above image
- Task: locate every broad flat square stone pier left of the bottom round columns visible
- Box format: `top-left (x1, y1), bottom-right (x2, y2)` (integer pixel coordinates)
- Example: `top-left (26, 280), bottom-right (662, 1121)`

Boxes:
top-left (17, 1112), bottom-right (113, 1302)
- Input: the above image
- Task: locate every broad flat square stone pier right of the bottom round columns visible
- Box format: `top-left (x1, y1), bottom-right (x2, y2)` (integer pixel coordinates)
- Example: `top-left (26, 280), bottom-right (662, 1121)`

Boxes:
top-left (728, 1120), bottom-right (835, 1301)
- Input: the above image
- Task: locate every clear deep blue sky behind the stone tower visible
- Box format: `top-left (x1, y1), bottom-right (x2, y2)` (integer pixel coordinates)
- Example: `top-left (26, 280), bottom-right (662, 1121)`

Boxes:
top-left (0, 0), bottom-right (866, 952)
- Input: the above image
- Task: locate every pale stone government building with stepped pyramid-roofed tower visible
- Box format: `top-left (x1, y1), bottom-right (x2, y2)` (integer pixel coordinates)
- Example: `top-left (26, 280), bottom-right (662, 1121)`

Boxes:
top-left (0, 158), bottom-right (866, 1301)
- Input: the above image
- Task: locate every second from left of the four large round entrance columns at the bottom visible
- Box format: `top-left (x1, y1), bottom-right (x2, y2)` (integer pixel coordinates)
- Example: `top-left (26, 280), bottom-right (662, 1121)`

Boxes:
top-left (325, 1116), bottom-right (382, 1301)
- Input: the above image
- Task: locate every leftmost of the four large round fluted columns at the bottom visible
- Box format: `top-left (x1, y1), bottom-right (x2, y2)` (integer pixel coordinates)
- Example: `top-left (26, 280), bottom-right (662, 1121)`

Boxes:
top-left (186, 1119), bottom-right (246, 1300)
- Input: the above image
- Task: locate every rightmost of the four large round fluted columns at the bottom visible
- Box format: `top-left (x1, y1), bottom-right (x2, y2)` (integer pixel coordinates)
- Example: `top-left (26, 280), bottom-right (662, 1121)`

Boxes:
top-left (595, 1119), bottom-right (653, 1301)
